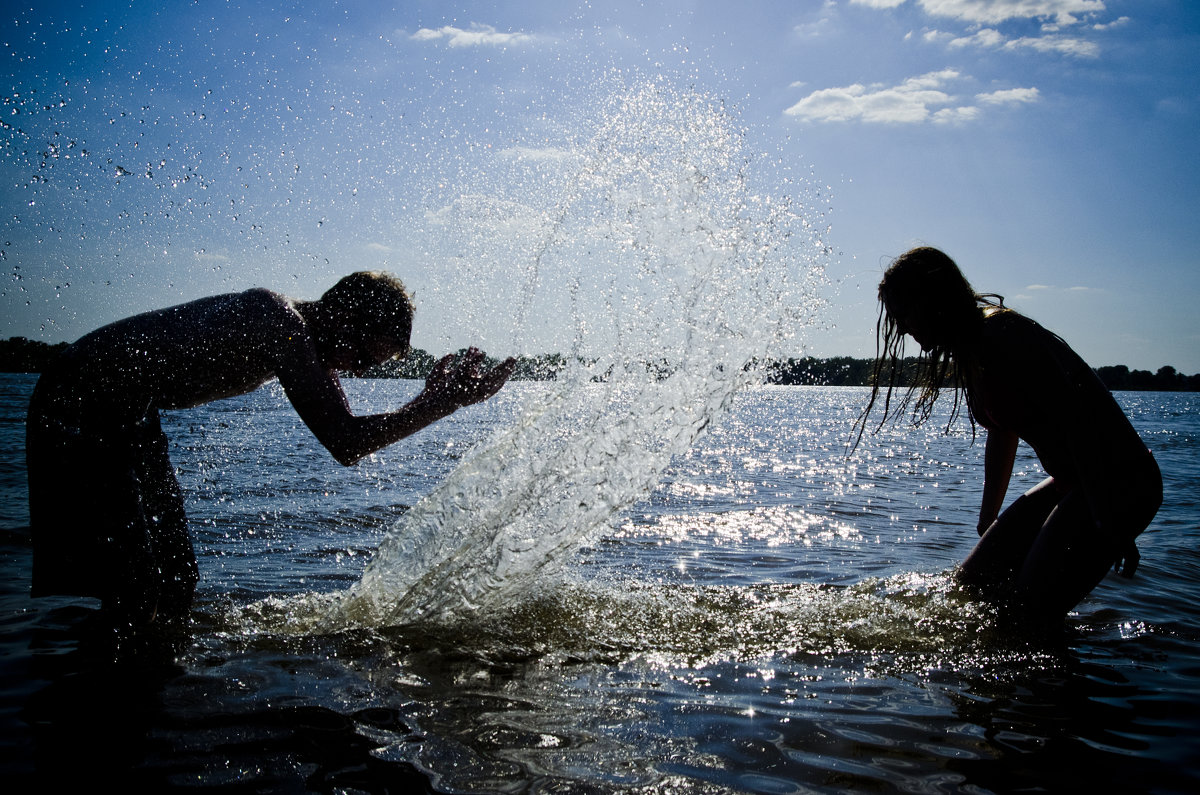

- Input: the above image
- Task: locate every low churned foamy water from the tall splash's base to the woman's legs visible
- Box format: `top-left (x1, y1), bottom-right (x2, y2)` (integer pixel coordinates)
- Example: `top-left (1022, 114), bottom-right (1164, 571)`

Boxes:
top-left (475, 573), bottom-right (1034, 675)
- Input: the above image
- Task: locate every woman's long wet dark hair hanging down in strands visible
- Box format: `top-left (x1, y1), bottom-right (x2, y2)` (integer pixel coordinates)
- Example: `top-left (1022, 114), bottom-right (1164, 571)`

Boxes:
top-left (851, 246), bottom-right (1007, 453)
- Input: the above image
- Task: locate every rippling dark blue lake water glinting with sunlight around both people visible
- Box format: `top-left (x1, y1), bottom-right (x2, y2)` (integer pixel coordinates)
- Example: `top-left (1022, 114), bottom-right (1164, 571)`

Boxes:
top-left (0, 376), bottom-right (1200, 793)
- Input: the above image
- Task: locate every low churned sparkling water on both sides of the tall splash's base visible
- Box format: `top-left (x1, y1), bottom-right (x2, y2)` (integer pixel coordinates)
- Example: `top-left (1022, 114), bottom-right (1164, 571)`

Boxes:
top-left (220, 572), bottom-right (1041, 676)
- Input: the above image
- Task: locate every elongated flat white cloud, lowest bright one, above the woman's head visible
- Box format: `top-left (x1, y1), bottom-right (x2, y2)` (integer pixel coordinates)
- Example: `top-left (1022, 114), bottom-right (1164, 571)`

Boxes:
top-left (784, 68), bottom-right (1038, 124)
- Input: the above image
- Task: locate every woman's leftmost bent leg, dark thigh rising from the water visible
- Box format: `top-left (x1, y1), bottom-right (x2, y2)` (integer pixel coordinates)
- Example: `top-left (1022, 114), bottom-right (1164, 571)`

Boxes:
top-left (958, 478), bottom-right (1062, 598)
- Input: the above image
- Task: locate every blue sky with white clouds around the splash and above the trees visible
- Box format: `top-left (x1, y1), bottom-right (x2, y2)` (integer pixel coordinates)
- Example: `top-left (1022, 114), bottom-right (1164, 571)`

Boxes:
top-left (0, 0), bottom-right (1200, 373)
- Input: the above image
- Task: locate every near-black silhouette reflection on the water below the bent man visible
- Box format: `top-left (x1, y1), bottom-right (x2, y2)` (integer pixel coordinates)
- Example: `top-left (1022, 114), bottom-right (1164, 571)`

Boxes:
top-left (0, 564), bottom-right (430, 793)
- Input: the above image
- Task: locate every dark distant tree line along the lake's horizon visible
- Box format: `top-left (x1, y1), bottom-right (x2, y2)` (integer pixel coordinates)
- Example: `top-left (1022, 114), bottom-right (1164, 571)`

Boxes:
top-left (0, 336), bottom-right (1200, 391)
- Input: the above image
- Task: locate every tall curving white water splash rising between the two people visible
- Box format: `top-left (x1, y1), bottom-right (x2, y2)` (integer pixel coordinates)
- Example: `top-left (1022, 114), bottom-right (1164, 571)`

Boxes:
top-left (319, 83), bottom-right (823, 626)
